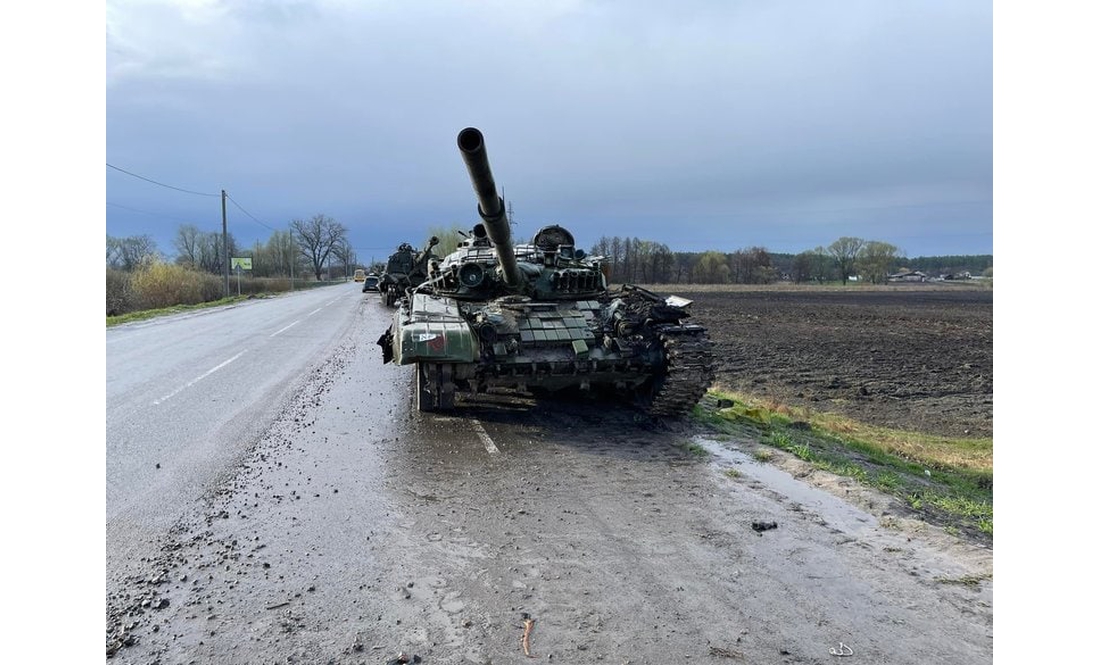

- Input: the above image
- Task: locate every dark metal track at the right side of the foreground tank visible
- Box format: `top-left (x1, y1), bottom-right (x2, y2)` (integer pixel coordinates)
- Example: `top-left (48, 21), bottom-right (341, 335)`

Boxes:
top-left (645, 325), bottom-right (714, 418)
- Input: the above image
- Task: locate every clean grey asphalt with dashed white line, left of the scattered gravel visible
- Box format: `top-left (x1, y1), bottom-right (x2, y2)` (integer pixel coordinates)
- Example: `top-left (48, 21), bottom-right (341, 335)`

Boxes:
top-left (107, 285), bottom-right (365, 572)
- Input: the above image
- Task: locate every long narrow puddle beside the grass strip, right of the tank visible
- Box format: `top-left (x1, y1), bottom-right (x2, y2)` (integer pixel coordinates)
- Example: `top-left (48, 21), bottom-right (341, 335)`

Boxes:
top-left (692, 436), bottom-right (878, 532)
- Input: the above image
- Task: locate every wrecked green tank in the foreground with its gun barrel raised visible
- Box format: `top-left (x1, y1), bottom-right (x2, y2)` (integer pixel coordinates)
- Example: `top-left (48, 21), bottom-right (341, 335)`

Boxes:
top-left (377, 128), bottom-right (714, 418)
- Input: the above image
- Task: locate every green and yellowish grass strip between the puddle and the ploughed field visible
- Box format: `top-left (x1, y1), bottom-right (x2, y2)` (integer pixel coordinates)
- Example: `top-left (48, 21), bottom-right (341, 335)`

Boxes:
top-left (694, 390), bottom-right (993, 542)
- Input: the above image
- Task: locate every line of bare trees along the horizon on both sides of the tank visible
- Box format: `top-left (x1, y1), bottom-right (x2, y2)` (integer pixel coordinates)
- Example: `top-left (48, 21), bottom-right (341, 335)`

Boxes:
top-left (107, 214), bottom-right (993, 284)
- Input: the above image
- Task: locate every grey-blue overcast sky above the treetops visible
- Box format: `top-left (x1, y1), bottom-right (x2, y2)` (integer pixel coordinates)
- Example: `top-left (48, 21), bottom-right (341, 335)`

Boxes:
top-left (106, 0), bottom-right (993, 262)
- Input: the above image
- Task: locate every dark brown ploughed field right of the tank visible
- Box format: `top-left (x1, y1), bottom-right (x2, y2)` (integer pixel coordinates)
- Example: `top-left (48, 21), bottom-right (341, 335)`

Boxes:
top-left (682, 285), bottom-right (993, 437)
